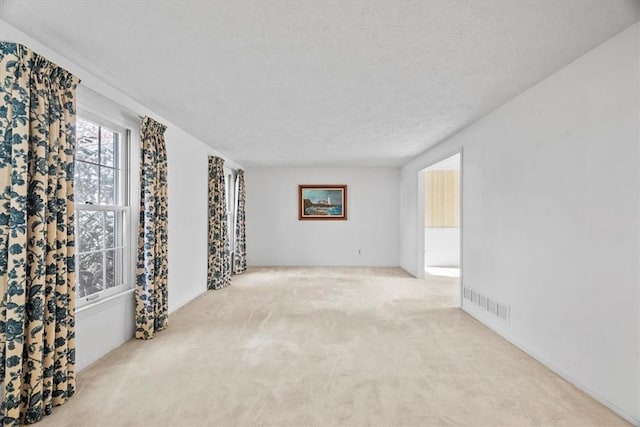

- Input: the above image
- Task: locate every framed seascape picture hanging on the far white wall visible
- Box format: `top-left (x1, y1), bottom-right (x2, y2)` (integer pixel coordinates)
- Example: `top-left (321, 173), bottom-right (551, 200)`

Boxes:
top-left (298, 185), bottom-right (347, 220)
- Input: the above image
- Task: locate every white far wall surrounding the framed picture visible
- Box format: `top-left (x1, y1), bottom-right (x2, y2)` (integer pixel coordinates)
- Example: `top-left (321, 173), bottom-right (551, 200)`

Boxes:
top-left (246, 168), bottom-right (400, 266)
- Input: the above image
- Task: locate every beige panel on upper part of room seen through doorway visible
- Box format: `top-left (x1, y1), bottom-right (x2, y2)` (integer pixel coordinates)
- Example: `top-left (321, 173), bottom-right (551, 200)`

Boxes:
top-left (424, 170), bottom-right (460, 228)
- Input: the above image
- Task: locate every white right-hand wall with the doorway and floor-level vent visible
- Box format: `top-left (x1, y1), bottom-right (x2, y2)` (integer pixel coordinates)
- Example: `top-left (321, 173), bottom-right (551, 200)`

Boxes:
top-left (401, 24), bottom-right (640, 423)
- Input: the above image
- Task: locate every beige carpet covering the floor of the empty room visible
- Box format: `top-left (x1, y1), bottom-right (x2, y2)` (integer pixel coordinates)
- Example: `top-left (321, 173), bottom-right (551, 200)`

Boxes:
top-left (39, 268), bottom-right (626, 426)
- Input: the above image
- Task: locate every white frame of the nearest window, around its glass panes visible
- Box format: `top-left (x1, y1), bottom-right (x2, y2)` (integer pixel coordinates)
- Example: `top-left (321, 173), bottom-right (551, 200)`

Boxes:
top-left (74, 111), bottom-right (135, 309)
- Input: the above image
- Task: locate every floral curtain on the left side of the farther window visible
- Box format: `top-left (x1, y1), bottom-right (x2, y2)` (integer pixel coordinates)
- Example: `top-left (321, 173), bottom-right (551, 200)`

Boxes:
top-left (207, 156), bottom-right (231, 289)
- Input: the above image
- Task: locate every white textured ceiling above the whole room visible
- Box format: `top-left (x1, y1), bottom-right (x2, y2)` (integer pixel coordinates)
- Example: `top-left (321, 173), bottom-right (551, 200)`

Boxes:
top-left (0, 0), bottom-right (640, 167)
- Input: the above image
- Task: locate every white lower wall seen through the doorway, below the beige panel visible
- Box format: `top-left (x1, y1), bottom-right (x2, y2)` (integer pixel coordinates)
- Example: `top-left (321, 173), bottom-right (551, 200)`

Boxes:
top-left (424, 228), bottom-right (460, 267)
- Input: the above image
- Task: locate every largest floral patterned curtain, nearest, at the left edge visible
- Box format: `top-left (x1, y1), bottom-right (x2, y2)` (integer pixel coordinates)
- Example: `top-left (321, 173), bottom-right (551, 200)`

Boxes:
top-left (0, 42), bottom-right (80, 426)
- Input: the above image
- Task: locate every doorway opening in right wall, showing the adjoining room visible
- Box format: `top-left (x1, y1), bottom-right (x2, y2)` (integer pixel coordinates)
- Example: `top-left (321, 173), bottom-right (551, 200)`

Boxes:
top-left (418, 152), bottom-right (462, 305)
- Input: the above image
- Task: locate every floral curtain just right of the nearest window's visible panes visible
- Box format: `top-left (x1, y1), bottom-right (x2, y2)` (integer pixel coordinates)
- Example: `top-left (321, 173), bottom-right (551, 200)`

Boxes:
top-left (135, 117), bottom-right (169, 339)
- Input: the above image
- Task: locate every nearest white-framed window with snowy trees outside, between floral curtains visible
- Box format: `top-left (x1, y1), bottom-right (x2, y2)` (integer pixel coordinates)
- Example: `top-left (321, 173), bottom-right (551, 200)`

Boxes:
top-left (74, 117), bottom-right (130, 306)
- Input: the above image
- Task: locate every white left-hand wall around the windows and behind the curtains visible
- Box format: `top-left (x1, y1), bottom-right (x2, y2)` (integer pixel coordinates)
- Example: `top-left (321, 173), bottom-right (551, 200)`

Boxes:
top-left (0, 20), bottom-right (239, 370)
